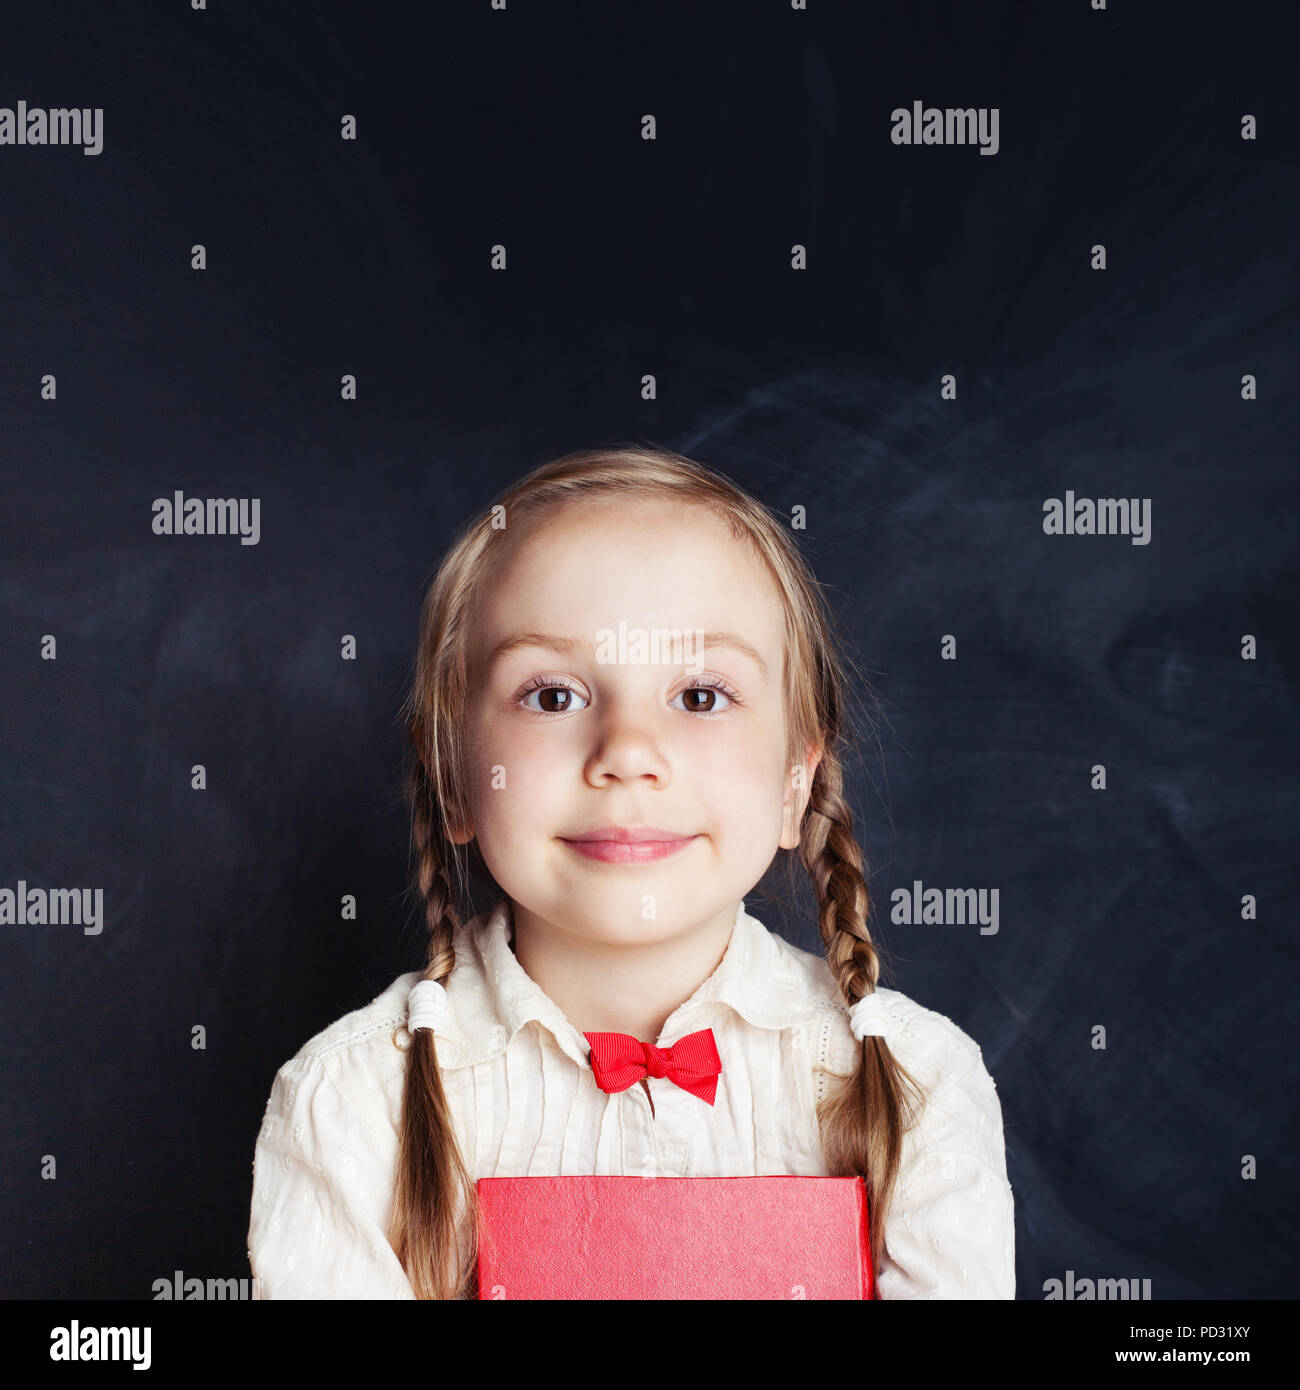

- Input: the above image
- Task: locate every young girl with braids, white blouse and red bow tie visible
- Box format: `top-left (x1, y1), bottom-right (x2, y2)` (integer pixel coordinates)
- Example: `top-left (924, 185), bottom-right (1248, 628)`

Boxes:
top-left (247, 448), bottom-right (1015, 1300)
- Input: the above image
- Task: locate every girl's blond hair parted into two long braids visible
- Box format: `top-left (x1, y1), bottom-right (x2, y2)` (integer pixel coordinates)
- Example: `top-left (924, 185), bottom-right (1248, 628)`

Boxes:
top-left (388, 445), bottom-right (923, 1298)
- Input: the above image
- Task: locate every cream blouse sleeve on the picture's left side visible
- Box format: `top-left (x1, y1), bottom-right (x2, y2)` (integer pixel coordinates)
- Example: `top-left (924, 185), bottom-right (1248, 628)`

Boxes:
top-left (247, 1049), bottom-right (414, 1298)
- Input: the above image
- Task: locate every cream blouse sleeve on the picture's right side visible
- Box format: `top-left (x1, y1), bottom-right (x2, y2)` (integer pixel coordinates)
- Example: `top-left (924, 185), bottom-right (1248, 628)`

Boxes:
top-left (877, 995), bottom-right (1015, 1300)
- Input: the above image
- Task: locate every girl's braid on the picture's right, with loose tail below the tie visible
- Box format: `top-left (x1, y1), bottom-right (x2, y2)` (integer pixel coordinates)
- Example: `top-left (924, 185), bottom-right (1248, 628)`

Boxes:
top-left (799, 749), bottom-right (922, 1270)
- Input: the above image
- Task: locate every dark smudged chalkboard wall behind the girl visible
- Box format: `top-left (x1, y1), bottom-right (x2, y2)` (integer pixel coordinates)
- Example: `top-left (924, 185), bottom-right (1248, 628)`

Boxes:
top-left (0, 0), bottom-right (1300, 1298)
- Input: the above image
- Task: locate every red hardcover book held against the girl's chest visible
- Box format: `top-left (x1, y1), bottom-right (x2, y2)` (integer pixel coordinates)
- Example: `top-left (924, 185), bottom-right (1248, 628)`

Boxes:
top-left (477, 1176), bottom-right (876, 1300)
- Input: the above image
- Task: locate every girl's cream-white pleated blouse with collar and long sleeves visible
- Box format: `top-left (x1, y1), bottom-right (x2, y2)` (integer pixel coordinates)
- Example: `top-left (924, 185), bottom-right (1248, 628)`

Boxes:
top-left (247, 899), bottom-right (1015, 1300)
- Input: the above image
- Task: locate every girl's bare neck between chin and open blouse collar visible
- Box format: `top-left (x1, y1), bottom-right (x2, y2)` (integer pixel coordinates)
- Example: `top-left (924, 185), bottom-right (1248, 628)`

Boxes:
top-left (512, 904), bottom-right (738, 1045)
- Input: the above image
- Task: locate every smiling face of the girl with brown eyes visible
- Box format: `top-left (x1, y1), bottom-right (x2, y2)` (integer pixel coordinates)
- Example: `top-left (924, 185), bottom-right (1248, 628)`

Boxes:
top-left (455, 498), bottom-right (818, 944)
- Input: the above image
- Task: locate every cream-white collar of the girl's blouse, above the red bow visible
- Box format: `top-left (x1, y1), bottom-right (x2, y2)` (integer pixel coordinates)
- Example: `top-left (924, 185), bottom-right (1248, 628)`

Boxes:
top-left (439, 898), bottom-right (836, 1068)
